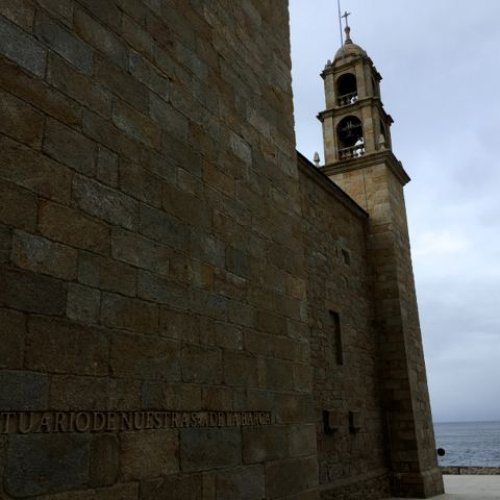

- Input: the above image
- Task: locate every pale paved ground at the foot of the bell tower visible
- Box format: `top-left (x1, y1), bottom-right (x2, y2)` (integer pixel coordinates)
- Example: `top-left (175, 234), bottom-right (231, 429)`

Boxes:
top-left (390, 475), bottom-right (500, 500)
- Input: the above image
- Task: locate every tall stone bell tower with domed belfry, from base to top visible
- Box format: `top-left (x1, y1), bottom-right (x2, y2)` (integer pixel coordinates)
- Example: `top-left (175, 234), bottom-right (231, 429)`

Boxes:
top-left (318, 18), bottom-right (443, 497)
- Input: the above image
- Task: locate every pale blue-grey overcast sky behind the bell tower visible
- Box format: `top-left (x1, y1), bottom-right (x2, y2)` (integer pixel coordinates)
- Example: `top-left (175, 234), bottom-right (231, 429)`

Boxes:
top-left (290, 0), bottom-right (500, 422)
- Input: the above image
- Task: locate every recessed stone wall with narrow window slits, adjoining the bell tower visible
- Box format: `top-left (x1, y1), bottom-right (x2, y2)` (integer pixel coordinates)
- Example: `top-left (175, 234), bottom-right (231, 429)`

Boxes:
top-left (300, 155), bottom-right (389, 499)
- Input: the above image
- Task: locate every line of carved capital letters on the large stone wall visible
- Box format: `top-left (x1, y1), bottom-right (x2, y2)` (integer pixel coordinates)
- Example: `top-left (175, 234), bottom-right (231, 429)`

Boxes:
top-left (0, 410), bottom-right (272, 434)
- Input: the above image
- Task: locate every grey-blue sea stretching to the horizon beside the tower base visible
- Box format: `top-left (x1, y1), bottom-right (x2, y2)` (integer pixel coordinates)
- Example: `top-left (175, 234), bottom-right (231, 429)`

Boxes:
top-left (434, 422), bottom-right (500, 467)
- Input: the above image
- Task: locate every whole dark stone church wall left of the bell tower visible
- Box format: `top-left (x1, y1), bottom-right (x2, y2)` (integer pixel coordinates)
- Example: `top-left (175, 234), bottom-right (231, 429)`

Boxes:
top-left (0, 0), bottom-right (442, 500)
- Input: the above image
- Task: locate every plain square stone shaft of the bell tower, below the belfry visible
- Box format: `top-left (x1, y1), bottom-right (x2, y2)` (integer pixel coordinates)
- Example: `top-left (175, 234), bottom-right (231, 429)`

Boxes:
top-left (328, 151), bottom-right (443, 497)
